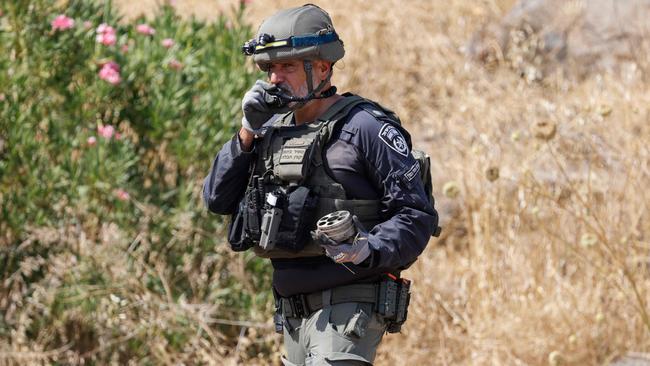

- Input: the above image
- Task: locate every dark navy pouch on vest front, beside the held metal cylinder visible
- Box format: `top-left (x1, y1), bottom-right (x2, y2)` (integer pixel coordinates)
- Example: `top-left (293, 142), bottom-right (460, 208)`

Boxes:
top-left (277, 186), bottom-right (318, 252)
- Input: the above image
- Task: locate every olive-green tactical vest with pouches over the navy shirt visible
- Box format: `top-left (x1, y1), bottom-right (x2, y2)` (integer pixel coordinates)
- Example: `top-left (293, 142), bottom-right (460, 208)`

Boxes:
top-left (229, 93), bottom-right (433, 258)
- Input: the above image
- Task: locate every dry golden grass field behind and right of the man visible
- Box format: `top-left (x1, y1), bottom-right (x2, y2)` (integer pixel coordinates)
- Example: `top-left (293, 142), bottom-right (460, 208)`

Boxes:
top-left (116, 0), bottom-right (650, 365)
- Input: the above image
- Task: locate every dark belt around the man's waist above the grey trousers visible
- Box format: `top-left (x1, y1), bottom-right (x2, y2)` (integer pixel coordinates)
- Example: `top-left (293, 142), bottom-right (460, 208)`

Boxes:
top-left (277, 283), bottom-right (377, 318)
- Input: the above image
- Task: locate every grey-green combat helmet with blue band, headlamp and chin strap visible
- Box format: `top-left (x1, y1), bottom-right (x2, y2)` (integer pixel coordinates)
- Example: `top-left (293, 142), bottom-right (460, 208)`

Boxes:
top-left (242, 4), bottom-right (345, 102)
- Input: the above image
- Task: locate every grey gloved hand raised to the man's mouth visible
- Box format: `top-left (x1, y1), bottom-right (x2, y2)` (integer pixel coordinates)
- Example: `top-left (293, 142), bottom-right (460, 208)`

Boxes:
top-left (241, 80), bottom-right (289, 133)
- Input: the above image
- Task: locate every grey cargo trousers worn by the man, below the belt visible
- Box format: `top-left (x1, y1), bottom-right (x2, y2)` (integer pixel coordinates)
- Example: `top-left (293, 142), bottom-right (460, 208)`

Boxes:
top-left (282, 291), bottom-right (386, 366)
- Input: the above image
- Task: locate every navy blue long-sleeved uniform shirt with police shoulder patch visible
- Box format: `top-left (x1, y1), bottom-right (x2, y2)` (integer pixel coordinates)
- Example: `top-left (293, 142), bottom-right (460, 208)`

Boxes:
top-left (203, 107), bottom-right (438, 296)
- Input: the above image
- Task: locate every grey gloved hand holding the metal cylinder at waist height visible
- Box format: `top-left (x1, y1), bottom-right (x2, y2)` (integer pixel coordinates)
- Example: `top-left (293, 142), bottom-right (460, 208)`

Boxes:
top-left (311, 216), bottom-right (371, 264)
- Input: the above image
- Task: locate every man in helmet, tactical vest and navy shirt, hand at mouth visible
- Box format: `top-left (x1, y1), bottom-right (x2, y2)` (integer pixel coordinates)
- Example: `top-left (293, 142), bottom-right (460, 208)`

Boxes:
top-left (203, 4), bottom-right (439, 365)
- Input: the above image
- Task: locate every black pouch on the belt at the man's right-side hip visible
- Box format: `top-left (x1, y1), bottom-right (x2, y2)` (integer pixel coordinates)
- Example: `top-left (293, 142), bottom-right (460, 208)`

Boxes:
top-left (376, 274), bottom-right (411, 333)
